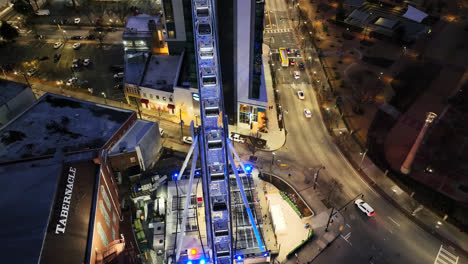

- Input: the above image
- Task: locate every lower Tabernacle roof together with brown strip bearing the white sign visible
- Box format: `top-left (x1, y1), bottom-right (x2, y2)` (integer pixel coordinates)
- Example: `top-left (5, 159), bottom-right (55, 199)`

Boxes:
top-left (0, 151), bottom-right (99, 264)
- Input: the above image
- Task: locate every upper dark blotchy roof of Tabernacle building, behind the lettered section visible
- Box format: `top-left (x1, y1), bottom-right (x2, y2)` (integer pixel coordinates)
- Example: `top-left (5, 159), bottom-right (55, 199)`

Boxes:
top-left (0, 94), bottom-right (134, 161)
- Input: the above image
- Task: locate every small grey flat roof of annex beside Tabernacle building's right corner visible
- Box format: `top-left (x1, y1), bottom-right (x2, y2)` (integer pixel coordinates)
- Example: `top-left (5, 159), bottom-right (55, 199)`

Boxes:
top-left (109, 119), bottom-right (154, 155)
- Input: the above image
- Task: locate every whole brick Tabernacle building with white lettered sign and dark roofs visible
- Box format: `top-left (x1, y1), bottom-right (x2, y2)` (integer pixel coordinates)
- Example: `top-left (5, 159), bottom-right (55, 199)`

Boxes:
top-left (0, 94), bottom-right (155, 264)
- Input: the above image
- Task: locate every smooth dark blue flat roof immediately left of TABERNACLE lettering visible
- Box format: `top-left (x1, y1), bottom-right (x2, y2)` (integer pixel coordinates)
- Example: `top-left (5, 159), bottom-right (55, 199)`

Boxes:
top-left (0, 159), bottom-right (62, 263)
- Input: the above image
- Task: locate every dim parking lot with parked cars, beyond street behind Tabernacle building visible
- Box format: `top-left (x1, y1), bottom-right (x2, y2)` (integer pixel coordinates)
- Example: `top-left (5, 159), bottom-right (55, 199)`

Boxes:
top-left (0, 40), bottom-right (125, 101)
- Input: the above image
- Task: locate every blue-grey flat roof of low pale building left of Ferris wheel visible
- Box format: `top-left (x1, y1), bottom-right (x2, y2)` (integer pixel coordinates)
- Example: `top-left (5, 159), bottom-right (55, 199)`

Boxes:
top-left (125, 53), bottom-right (180, 92)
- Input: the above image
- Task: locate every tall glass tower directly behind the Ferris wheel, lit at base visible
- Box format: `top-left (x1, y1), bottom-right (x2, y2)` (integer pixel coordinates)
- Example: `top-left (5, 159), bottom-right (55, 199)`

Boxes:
top-left (162, 0), bottom-right (268, 131)
